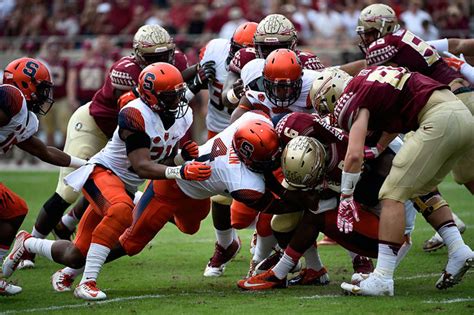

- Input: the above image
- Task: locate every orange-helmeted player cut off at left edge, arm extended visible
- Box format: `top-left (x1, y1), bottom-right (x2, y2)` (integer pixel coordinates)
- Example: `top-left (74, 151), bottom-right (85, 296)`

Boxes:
top-left (0, 58), bottom-right (85, 295)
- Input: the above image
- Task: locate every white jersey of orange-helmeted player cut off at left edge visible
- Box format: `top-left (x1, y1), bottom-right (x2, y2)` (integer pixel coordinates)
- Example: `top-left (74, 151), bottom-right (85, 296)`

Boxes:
top-left (0, 84), bottom-right (39, 154)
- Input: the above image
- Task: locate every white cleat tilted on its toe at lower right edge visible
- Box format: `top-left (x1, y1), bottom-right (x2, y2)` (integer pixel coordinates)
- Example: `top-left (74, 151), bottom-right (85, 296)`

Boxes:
top-left (436, 245), bottom-right (474, 290)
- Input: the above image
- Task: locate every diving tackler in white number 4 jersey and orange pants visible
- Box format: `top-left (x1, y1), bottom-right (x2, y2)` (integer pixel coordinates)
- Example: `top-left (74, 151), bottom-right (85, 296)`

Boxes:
top-left (43, 112), bottom-right (308, 298)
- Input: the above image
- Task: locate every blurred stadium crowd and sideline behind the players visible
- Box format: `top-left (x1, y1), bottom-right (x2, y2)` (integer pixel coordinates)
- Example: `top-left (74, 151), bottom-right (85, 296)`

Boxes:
top-left (0, 0), bottom-right (474, 168)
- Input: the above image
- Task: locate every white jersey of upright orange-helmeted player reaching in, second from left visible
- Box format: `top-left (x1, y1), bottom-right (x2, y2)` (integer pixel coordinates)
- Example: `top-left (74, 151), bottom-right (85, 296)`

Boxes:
top-left (89, 98), bottom-right (193, 191)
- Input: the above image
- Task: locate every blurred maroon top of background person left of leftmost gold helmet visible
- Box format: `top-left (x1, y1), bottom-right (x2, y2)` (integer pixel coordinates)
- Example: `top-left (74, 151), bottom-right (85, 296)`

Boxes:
top-left (74, 56), bottom-right (107, 102)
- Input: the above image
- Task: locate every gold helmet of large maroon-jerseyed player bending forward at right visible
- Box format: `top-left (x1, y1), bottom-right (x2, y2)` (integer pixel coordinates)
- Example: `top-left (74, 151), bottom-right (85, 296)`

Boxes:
top-left (309, 68), bottom-right (352, 115)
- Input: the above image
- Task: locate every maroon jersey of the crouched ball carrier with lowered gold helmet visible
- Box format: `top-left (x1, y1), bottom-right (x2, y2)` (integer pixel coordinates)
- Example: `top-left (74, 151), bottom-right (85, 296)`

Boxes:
top-left (275, 113), bottom-right (348, 188)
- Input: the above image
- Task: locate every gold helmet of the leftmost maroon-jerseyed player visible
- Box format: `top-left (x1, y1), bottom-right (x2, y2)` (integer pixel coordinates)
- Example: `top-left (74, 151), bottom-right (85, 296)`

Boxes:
top-left (133, 25), bottom-right (176, 66)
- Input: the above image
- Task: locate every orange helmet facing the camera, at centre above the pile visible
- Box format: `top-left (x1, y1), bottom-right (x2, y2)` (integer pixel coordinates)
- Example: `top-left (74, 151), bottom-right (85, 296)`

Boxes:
top-left (263, 49), bottom-right (303, 107)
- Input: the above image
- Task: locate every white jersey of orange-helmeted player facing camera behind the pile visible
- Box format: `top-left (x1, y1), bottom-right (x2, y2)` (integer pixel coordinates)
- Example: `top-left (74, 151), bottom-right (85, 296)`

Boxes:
top-left (241, 59), bottom-right (319, 117)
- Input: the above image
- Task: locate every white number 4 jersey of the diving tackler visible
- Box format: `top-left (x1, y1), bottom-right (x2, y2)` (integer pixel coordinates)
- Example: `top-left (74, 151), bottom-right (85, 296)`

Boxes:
top-left (176, 112), bottom-right (271, 199)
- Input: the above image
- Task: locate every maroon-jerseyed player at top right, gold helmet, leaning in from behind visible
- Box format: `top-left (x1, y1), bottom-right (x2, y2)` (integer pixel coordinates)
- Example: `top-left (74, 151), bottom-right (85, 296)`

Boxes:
top-left (356, 4), bottom-right (474, 251)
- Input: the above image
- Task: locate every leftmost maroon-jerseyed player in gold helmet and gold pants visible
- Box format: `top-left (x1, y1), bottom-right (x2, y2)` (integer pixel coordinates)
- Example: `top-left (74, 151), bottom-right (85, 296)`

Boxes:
top-left (27, 25), bottom-right (191, 268)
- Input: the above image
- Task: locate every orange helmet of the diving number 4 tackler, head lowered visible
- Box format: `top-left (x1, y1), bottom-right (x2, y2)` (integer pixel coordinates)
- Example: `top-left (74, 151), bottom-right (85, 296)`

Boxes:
top-left (232, 119), bottom-right (281, 173)
